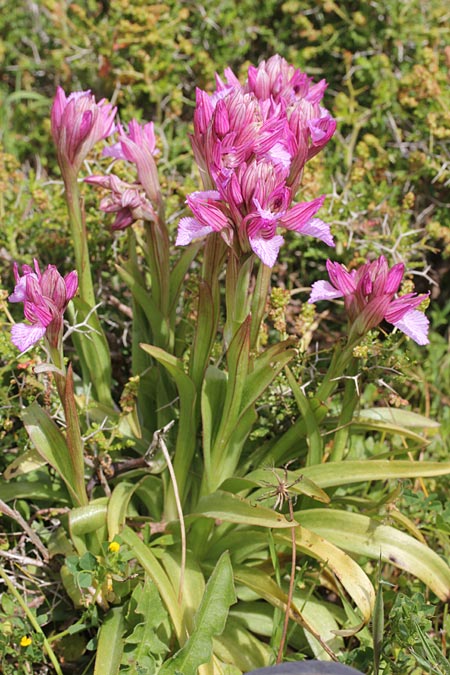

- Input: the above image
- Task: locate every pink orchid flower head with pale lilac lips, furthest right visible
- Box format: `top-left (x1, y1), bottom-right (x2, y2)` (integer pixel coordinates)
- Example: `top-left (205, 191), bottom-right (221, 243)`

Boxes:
top-left (308, 256), bottom-right (429, 345)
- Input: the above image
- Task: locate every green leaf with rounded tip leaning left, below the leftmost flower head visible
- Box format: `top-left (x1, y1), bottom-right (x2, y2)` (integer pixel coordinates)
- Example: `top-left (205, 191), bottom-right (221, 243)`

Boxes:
top-left (22, 401), bottom-right (83, 506)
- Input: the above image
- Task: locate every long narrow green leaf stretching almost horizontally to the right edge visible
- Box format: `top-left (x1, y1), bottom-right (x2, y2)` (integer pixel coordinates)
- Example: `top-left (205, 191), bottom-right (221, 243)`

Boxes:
top-left (246, 459), bottom-right (450, 489)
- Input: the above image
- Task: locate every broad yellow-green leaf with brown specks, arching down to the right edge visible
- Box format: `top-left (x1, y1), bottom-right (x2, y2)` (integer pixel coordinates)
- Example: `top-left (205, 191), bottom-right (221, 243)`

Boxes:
top-left (296, 509), bottom-right (450, 602)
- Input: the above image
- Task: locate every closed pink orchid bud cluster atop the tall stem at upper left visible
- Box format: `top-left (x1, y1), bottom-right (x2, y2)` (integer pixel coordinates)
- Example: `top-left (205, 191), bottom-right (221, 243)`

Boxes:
top-left (51, 87), bottom-right (117, 177)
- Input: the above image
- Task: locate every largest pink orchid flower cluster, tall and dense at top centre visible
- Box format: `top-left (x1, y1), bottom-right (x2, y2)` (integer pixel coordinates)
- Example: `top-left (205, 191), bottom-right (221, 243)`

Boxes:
top-left (177, 56), bottom-right (336, 267)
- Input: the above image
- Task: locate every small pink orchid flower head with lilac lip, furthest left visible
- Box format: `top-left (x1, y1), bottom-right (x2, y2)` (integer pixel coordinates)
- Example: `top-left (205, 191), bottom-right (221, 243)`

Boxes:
top-left (8, 260), bottom-right (78, 352)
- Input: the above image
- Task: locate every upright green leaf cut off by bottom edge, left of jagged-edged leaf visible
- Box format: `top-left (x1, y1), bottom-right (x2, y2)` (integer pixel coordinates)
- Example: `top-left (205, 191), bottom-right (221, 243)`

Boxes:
top-left (94, 607), bottom-right (125, 675)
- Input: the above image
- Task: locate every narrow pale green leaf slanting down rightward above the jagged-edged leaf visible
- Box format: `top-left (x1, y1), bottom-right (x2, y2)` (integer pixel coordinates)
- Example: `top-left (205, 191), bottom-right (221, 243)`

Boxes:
top-left (120, 527), bottom-right (186, 645)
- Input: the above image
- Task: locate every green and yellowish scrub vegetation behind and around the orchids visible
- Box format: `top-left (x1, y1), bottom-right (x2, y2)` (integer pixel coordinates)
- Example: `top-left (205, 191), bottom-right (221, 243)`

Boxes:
top-left (0, 0), bottom-right (450, 675)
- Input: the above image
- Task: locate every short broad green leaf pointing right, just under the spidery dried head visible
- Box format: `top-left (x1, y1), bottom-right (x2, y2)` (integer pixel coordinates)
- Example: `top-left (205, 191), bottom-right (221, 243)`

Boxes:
top-left (191, 490), bottom-right (295, 528)
